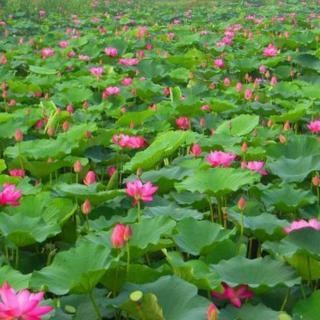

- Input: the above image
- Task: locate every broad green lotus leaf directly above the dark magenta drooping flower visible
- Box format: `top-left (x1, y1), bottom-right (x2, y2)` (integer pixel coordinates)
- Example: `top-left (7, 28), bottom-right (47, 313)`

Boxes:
top-left (212, 256), bottom-right (300, 288)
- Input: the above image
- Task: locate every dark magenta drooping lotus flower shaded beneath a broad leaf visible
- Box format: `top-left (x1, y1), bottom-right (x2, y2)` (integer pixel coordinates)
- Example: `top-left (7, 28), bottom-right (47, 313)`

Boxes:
top-left (211, 283), bottom-right (253, 308)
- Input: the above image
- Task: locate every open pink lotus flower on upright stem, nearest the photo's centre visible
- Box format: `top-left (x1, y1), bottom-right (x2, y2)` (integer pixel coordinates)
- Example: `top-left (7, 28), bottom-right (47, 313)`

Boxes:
top-left (126, 180), bottom-right (158, 205)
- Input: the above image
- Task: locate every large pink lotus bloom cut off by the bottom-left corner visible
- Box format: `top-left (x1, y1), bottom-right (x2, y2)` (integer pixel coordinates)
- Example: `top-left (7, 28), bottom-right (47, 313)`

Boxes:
top-left (0, 282), bottom-right (53, 320)
